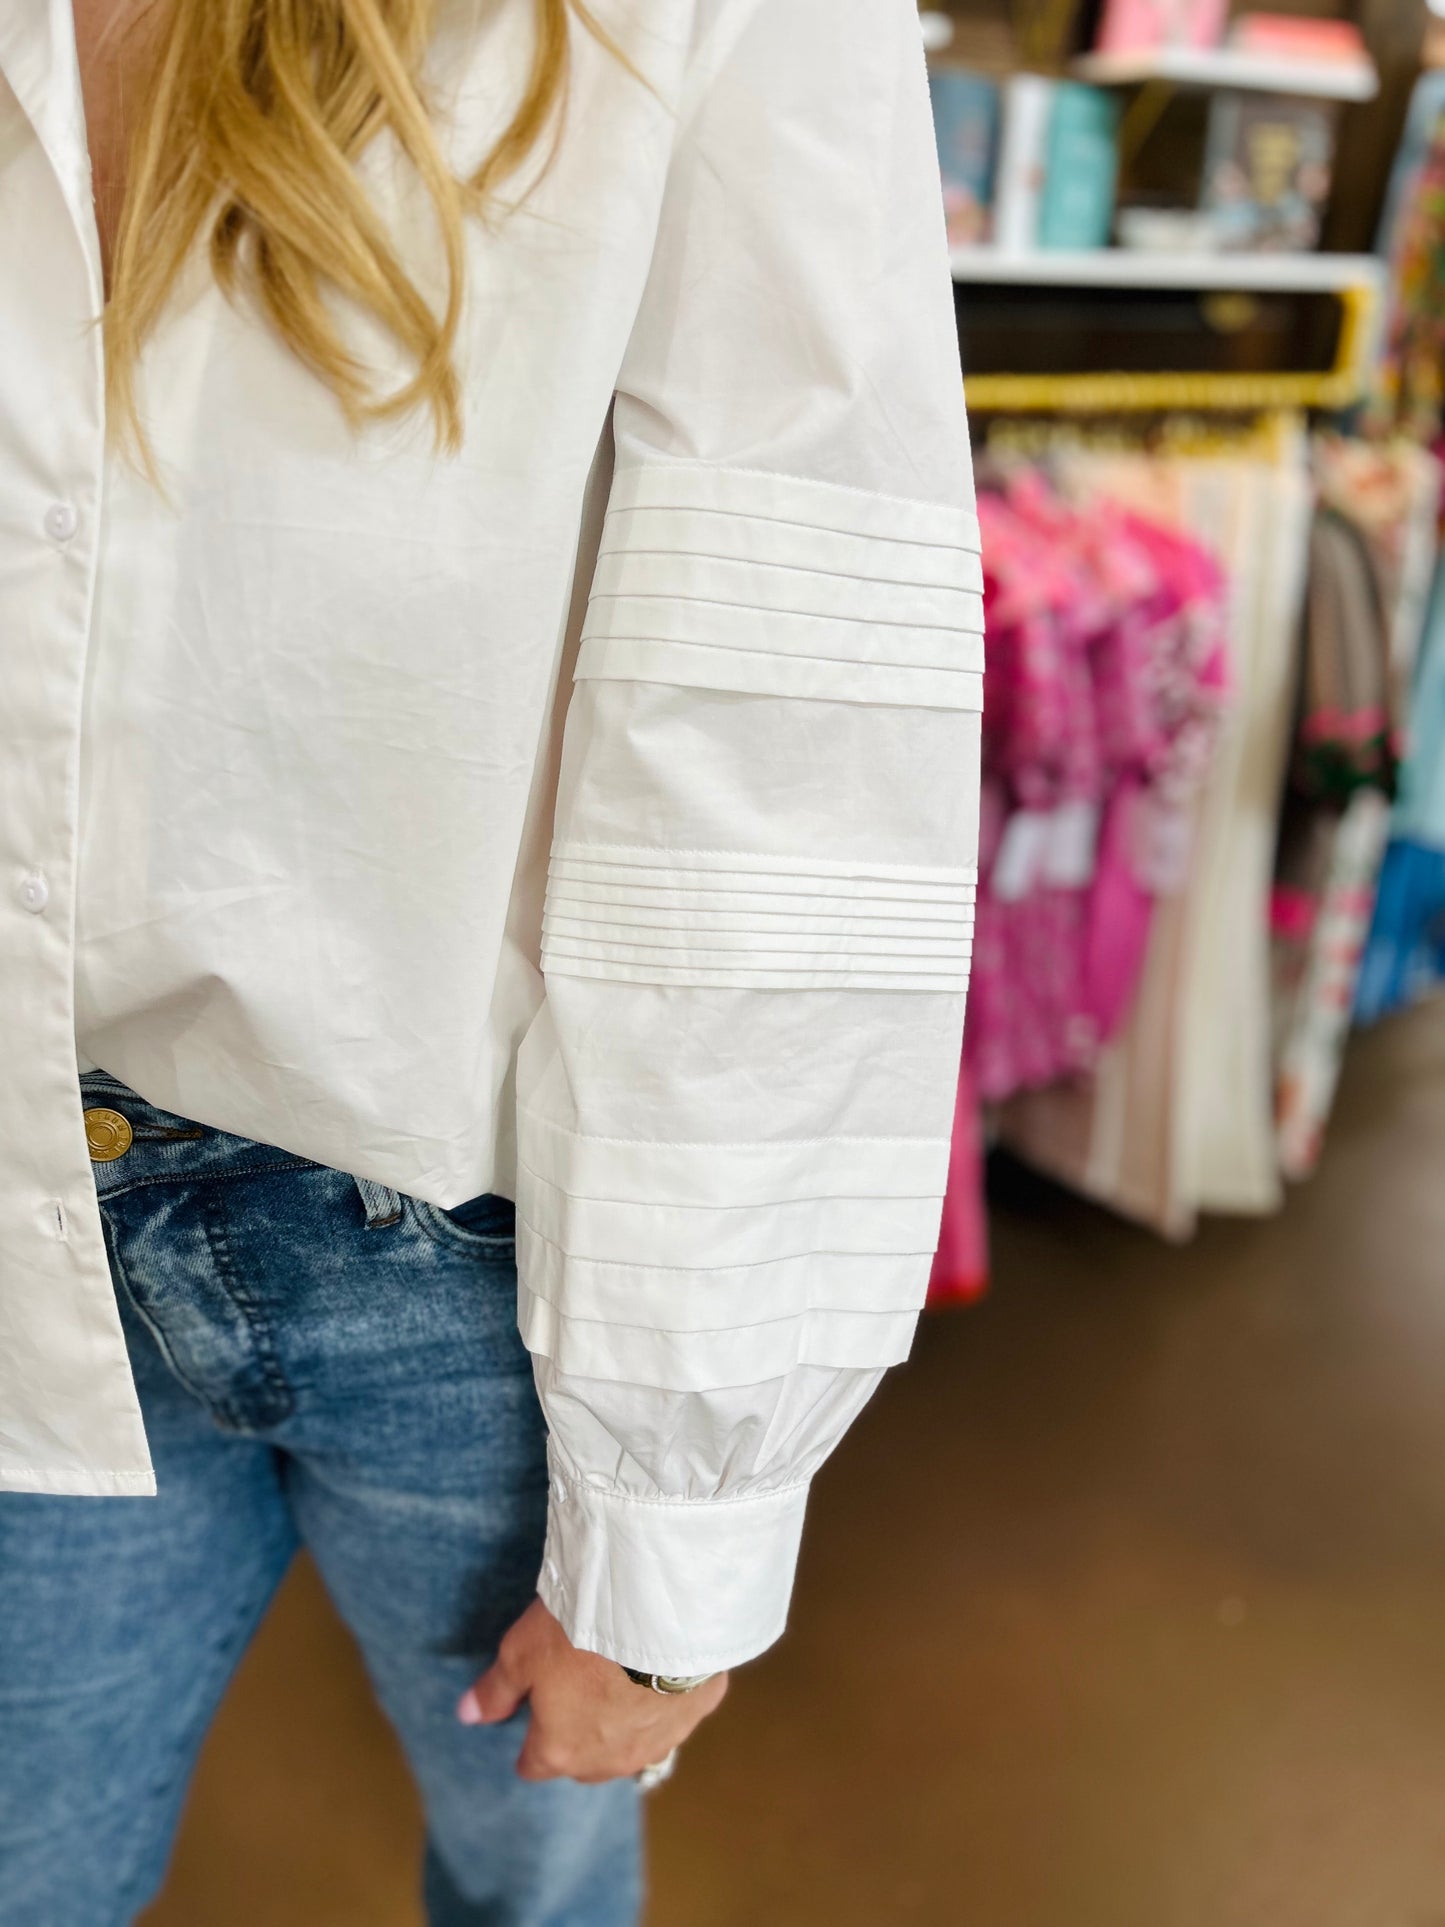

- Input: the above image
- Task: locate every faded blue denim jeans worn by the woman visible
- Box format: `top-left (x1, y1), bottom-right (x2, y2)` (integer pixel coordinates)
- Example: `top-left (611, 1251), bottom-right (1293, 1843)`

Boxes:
top-left (0, 1073), bottom-right (640, 1927)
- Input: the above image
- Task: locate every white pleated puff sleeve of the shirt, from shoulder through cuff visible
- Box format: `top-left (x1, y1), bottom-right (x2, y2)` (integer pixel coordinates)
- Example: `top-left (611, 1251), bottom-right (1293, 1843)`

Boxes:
top-left (518, 0), bottom-right (983, 1673)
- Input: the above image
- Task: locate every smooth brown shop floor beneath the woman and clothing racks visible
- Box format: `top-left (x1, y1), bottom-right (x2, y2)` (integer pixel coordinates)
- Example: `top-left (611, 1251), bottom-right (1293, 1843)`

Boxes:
top-left (141, 1006), bottom-right (1445, 1927)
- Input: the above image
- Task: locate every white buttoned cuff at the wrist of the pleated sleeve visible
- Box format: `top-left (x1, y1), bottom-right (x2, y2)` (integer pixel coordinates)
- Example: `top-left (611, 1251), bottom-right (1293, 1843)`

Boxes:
top-left (538, 1455), bottom-right (807, 1675)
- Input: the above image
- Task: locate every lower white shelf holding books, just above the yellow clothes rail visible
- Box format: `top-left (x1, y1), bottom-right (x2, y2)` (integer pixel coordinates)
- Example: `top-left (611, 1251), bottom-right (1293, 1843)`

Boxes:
top-left (954, 247), bottom-right (1383, 295)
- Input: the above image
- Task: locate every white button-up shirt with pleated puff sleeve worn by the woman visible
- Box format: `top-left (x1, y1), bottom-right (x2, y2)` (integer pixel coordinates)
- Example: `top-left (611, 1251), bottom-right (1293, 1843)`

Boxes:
top-left (0, 0), bottom-right (983, 1673)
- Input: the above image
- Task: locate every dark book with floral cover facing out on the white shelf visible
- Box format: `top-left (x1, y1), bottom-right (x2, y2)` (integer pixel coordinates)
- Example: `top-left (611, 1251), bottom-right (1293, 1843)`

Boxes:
top-left (1200, 91), bottom-right (1335, 252)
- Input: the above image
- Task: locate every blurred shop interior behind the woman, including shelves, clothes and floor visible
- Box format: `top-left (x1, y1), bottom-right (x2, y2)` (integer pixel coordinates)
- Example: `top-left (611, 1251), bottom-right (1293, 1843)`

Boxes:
top-left (144, 0), bottom-right (1445, 1927)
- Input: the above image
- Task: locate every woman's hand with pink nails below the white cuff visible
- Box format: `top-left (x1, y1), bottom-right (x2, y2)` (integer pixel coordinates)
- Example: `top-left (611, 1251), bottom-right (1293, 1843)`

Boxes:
top-left (457, 1599), bottom-right (728, 1784)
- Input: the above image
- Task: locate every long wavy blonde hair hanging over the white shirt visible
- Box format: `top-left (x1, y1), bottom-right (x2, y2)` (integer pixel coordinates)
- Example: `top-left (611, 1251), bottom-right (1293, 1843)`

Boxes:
top-left (104, 0), bottom-right (617, 454)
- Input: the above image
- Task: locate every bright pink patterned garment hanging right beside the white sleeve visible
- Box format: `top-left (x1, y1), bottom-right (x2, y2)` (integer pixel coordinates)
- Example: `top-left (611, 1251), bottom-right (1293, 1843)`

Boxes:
top-left (965, 468), bottom-right (1225, 1100)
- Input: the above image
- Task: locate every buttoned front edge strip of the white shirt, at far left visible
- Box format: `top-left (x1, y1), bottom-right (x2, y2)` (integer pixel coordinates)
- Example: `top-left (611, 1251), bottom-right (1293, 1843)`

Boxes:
top-left (0, 0), bottom-right (154, 1493)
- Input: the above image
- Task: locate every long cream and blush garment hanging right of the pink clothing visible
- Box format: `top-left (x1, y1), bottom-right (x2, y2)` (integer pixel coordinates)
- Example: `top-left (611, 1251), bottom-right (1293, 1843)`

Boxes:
top-left (1000, 422), bottom-right (1310, 1237)
